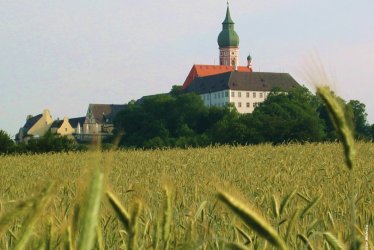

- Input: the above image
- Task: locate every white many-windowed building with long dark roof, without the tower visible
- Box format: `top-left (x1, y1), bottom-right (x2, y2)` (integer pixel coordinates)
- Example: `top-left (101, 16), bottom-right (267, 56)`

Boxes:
top-left (185, 71), bottom-right (299, 113)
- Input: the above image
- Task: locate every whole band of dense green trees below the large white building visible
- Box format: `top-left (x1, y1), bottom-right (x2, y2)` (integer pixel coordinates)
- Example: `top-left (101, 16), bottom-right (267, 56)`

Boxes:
top-left (115, 86), bottom-right (372, 148)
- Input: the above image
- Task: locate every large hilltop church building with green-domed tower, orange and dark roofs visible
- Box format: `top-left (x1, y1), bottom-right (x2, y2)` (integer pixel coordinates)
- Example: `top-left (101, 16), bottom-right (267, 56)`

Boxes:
top-left (182, 2), bottom-right (299, 113)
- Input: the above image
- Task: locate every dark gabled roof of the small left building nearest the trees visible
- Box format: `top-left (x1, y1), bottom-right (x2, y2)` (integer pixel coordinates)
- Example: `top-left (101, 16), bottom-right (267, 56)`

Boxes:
top-left (89, 104), bottom-right (126, 124)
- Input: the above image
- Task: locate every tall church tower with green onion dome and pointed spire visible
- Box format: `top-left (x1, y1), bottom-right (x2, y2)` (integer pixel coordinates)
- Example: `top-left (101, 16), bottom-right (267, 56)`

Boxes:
top-left (218, 2), bottom-right (239, 68)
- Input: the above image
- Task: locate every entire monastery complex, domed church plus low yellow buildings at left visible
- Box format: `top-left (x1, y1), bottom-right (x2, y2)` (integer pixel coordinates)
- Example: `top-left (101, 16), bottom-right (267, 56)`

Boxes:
top-left (16, 2), bottom-right (299, 142)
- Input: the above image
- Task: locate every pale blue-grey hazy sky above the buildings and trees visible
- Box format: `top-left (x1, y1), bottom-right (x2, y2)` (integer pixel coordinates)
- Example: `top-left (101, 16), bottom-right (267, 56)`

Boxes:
top-left (0, 0), bottom-right (374, 136)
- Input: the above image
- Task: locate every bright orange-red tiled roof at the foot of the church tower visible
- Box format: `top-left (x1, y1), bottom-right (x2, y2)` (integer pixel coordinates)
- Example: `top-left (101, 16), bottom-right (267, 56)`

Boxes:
top-left (183, 64), bottom-right (252, 89)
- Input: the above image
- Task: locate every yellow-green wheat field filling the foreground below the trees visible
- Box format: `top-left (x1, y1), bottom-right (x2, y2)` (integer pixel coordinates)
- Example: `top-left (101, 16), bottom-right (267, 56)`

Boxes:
top-left (0, 143), bottom-right (374, 249)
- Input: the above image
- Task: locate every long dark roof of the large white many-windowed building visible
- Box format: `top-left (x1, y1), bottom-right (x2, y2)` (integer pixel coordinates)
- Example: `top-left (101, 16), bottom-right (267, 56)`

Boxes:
top-left (185, 71), bottom-right (299, 94)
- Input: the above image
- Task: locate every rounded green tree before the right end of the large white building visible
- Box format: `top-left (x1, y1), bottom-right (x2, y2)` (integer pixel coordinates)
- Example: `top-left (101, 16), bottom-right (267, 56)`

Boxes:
top-left (250, 87), bottom-right (325, 143)
